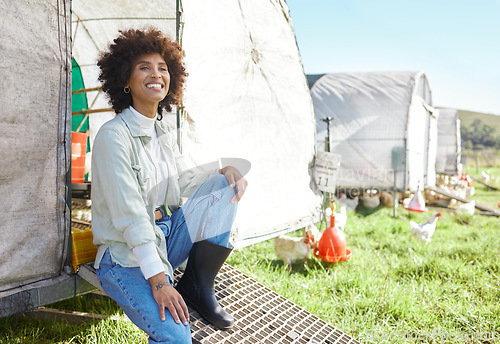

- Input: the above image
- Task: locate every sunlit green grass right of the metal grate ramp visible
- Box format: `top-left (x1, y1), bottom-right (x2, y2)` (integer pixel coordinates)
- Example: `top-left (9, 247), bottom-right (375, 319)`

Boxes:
top-left (229, 208), bottom-right (500, 343)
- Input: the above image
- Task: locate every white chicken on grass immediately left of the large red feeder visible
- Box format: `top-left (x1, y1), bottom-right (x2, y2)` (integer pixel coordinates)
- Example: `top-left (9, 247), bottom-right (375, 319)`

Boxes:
top-left (274, 224), bottom-right (320, 271)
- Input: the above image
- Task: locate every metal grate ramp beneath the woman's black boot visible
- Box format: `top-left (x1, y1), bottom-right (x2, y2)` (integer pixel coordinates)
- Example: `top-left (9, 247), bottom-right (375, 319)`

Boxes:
top-left (72, 200), bottom-right (359, 344)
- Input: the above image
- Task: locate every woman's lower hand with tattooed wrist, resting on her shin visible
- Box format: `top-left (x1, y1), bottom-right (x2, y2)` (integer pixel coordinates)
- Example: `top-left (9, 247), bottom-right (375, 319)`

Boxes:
top-left (149, 272), bottom-right (189, 325)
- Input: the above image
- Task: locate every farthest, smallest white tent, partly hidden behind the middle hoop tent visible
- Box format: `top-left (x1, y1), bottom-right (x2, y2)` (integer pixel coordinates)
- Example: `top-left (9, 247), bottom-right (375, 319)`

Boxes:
top-left (436, 109), bottom-right (462, 174)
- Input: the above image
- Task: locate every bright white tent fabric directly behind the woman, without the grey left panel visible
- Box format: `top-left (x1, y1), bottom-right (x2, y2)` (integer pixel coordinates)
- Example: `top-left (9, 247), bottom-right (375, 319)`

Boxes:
top-left (73, 0), bottom-right (321, 247)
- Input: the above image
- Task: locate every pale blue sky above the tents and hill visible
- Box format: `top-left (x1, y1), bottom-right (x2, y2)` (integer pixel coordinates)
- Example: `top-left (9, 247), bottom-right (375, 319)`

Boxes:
top-left (286, 0), bottom-right (500, 115)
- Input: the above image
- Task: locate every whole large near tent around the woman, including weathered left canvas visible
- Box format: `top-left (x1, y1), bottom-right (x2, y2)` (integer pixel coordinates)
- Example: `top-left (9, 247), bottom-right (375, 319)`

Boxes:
top-left (0, 0), bottom-right (321, 316)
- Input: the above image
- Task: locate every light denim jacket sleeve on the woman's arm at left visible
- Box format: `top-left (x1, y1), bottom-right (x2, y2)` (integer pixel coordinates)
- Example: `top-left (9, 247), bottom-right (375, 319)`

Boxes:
top-left (92, 128), bottom-right (155, 249)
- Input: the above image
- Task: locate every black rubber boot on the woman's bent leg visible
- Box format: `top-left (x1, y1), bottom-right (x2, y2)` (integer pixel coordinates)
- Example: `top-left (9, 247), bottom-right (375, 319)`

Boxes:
top-left (175, 241), bottom-right (234, 330)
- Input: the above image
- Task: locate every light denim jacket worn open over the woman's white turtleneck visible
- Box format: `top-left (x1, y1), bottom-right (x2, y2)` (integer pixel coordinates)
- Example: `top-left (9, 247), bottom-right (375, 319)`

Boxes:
top-left (92, 109), bottom-right (217, 281)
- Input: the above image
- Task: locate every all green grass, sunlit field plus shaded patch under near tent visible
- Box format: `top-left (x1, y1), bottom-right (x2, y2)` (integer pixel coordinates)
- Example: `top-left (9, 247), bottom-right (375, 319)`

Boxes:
top-left (0, 168), bottom-right (500, 344)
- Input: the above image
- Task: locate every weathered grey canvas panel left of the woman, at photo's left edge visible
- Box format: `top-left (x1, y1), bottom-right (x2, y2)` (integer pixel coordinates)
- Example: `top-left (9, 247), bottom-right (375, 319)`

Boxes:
top-left (0, 0), bottom-right (71, 297)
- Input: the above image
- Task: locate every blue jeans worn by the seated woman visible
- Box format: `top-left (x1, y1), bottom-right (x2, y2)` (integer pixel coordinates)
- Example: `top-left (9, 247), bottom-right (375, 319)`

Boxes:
top-left (97, 175), bottom-right (237, 344)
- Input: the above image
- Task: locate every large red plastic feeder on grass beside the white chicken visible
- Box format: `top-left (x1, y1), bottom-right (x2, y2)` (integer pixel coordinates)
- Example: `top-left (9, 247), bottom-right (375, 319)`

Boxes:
top-left (314, 215), bottom-right (352, 263)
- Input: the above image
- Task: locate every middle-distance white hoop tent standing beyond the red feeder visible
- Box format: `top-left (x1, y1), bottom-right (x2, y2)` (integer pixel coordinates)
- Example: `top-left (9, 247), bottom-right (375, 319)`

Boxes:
top-left (308, 72), bottom-right (438, 191)
